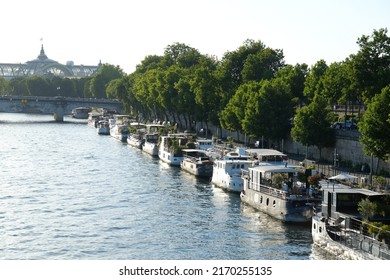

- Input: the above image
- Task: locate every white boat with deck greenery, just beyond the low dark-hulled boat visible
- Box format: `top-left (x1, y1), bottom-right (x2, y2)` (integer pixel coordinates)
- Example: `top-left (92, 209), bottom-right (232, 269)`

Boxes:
top-left (158, 134), bottom-right (188, 166)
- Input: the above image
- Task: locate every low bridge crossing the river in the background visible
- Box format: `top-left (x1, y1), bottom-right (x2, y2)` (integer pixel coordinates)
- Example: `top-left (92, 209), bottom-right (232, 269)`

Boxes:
top-left (0, 95), bottom-right (123, 122)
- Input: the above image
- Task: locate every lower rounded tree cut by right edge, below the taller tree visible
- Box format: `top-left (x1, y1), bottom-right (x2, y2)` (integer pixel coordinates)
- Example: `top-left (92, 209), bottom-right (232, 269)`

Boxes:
top-left (359, 87), bottom-right (390, 160)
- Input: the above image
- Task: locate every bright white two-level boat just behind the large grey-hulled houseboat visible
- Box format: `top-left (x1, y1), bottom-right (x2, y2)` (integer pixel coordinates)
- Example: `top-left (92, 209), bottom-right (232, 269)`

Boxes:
top-left (211, 152), bottom-right (255, 193)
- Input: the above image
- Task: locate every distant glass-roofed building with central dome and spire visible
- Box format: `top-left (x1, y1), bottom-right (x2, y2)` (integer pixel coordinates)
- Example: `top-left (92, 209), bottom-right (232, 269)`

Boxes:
top-left (0, 45), bottom-right (101, 80)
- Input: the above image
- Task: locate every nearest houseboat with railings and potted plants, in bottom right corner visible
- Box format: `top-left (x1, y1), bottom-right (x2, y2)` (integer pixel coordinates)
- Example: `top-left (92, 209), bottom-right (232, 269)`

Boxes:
top-left (311, 180), bottom-right (390, 260)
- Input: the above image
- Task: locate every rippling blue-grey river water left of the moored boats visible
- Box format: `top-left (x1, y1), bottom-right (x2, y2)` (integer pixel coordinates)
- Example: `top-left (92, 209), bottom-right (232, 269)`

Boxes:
top-left (0, 113), bottom-right (325, 260)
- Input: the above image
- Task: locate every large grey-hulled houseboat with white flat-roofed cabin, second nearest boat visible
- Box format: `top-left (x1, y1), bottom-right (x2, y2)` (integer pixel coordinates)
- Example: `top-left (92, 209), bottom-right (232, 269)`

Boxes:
top-left (240, 164), bottom-right (320, 223)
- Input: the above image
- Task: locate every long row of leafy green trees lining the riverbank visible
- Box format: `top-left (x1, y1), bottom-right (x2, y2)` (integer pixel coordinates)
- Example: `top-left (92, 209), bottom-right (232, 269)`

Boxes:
top-left (0, 29), bottom-right (390, 160)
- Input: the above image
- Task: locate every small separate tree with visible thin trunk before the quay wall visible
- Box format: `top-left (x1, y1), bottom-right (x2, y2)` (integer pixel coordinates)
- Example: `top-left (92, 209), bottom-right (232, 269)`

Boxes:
top-left (291, 94), bottom-right (335, 160)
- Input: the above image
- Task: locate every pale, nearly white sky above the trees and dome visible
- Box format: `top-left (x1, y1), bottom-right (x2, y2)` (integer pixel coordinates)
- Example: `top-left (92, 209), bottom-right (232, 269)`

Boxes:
top-left (0, 0), bottom-right (390, 73)
